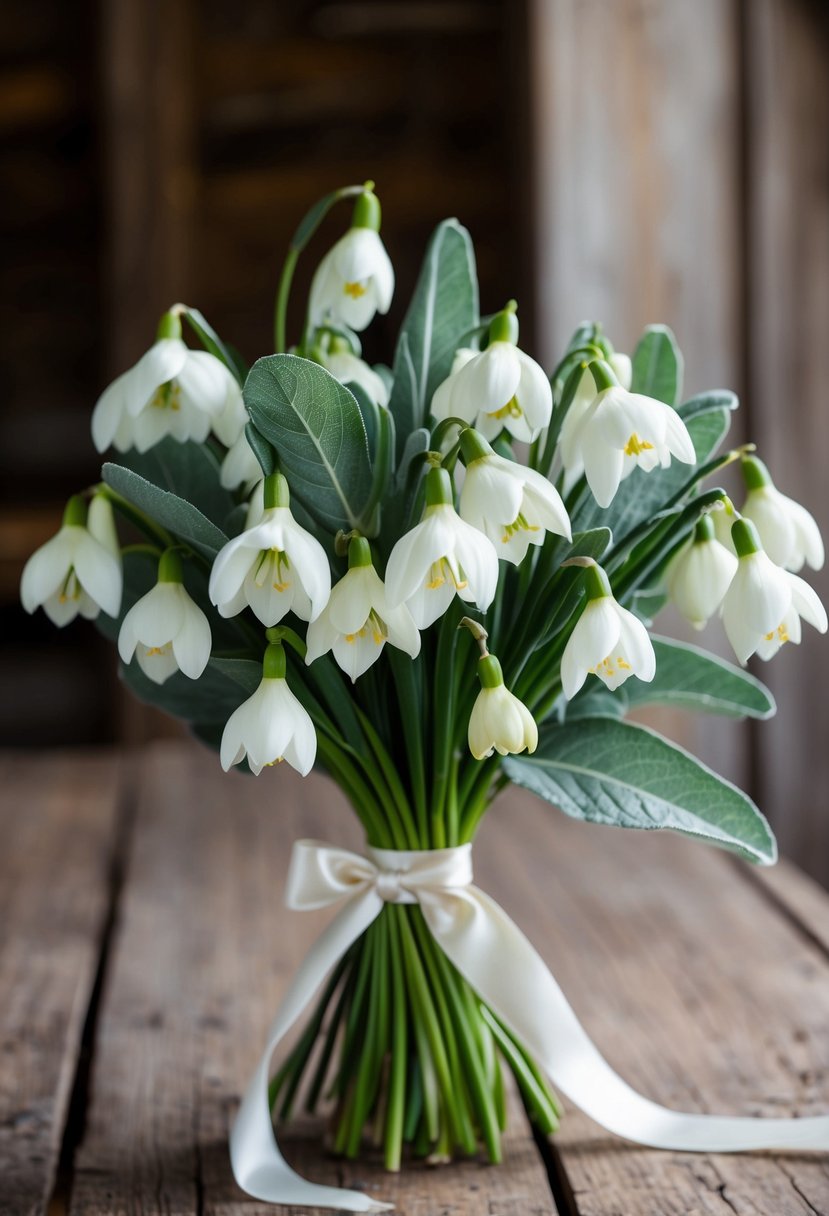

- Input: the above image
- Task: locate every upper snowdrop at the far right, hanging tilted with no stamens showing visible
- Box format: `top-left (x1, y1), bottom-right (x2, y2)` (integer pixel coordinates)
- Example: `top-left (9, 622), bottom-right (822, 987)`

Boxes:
top-left (741, 456), bottom-right (824, 572)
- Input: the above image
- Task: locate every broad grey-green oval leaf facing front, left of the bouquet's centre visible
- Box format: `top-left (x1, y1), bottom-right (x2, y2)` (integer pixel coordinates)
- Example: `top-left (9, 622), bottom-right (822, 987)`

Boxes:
top-left (244, 355), bottom-right (372, 533)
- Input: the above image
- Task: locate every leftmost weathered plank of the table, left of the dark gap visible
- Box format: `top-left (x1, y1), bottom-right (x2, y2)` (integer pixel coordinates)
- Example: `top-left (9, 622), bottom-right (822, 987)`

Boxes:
top-left (0, 753), bottom-right (123, 1216)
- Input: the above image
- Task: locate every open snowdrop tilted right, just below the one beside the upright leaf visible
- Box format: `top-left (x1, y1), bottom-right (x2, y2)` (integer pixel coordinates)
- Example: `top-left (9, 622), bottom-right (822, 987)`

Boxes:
top-left (459, 429), bottom-right (571, 565)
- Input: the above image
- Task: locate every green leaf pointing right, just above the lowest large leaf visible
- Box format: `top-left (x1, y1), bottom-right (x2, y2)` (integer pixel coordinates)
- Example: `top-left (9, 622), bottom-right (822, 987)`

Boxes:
top-left (625, 637), bottom-right (777, 720)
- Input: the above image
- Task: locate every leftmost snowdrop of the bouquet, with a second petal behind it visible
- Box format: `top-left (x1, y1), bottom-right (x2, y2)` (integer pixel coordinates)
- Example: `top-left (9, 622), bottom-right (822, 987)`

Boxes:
top-left (21, 494), bottom-right (123, 627)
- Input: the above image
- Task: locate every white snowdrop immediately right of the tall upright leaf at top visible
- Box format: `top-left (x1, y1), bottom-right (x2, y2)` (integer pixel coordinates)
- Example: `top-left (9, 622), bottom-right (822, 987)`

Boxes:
top-left (430, 302), bottom-right (553, 443)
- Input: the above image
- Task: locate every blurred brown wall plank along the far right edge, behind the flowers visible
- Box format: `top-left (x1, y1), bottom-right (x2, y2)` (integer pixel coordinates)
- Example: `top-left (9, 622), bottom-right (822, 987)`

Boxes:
top-left (744, 0), bottom-right (829, 884)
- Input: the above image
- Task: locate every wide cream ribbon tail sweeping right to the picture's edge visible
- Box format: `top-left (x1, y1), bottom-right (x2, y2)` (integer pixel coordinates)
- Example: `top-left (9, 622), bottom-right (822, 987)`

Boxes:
top-left (419, 886), bottom-right (829, 1153)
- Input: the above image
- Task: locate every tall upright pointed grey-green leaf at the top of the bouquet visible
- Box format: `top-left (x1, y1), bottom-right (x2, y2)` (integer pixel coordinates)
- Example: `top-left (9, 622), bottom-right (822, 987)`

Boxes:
top-left (389, 219), bottom-right (479, 454)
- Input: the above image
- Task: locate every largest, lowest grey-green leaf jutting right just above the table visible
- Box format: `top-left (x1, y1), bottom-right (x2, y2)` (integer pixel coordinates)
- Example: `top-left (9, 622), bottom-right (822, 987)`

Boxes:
top-left (503, 717), bottom-right (777, 865)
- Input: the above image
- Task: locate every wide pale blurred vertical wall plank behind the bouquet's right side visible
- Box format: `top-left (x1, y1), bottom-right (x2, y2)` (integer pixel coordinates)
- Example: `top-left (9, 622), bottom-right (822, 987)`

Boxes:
top-left (529, 0), bottom-right (750, 786)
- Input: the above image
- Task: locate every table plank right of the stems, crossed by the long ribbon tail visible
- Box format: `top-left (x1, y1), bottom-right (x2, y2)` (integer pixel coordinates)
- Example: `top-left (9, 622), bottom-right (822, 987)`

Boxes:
top-left (476, 795), bottom-right (829, 1216)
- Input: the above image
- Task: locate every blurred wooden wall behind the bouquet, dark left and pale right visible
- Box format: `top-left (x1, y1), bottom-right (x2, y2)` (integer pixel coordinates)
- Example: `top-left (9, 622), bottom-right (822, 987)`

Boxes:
top-left (0, 0), bottom-right (829, 882)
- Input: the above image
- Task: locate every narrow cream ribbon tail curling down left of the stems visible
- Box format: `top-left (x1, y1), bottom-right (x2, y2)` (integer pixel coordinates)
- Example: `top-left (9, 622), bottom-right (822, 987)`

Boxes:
top-left (230, 890), bottom-right (393, 1212)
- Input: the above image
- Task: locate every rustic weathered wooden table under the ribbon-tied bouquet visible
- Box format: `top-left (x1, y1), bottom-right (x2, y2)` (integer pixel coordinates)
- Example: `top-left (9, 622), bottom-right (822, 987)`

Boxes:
top-left (0, 743), bottom-right (829, 1216)
